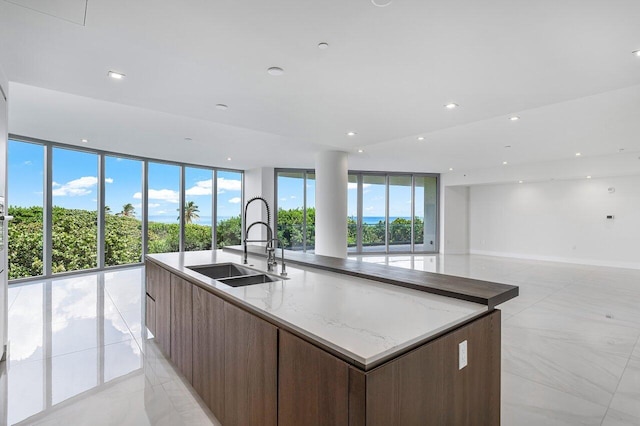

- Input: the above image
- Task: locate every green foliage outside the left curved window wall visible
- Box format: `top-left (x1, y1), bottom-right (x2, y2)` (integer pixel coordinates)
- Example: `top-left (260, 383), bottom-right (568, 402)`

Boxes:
top-left (8, 207), bottom-right (241, 279)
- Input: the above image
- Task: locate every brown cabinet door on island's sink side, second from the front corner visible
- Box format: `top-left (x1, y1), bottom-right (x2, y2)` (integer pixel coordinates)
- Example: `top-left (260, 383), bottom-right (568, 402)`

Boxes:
top-left (224, 302), bottom-right (278, 426)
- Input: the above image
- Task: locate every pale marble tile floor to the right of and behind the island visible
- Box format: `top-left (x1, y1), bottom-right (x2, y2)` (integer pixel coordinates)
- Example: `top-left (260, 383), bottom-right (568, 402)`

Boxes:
top-left (353, 255), bottom-right (640, 426)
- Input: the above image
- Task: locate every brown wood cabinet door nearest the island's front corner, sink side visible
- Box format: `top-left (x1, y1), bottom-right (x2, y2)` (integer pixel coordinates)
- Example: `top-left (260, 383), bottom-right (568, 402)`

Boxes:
top-left (278, 330), bottom-right (349, 426)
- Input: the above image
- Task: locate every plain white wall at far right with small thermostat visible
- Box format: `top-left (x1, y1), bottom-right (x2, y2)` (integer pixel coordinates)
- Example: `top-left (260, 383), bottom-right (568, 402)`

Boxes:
top-left (468, 175), bottom-right (640, 268)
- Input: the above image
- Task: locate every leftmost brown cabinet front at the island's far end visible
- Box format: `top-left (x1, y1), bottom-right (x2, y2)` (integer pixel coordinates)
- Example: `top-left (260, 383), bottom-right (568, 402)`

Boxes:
top-left (145, 262), bottom-right (171, 356)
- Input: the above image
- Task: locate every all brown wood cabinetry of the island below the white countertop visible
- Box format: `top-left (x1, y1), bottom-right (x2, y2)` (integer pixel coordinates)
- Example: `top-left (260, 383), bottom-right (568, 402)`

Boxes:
top-left (145, 262), bottom-right (501, 426)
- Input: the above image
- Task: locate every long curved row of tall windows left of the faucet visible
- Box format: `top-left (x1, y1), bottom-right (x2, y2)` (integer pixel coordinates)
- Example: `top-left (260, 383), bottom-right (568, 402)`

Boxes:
top-left (6, 136), bottom-right (243, 280)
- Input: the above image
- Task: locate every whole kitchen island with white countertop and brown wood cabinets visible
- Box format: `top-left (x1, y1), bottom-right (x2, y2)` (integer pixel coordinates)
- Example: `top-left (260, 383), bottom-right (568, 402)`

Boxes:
top-left (146, 250), bottom-right (517, 425)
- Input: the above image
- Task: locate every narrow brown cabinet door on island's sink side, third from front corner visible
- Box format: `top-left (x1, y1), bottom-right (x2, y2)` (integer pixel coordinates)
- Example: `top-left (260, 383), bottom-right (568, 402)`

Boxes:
top-left (192, 286), bottom-right (225, 424)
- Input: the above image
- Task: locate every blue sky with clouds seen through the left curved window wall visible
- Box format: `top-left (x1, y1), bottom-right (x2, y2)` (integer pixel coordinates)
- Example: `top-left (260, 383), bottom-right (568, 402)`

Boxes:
top-left (8, 141), bottom-right (242, 223)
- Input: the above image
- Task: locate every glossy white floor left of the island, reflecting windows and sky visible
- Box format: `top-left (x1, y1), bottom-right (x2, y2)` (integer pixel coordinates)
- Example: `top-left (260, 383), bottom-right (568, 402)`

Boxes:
top-left (0, 267), bottom-right (218, 425)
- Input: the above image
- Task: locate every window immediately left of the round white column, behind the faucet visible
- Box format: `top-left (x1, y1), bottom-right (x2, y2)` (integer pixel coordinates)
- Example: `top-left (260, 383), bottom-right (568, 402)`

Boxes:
top-left (276, 170), bottom-right (316, 251)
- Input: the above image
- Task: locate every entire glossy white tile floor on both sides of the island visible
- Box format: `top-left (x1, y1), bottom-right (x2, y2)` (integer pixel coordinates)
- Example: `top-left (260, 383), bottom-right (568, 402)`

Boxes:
top-left (0, 255), bottom-right (640, 426)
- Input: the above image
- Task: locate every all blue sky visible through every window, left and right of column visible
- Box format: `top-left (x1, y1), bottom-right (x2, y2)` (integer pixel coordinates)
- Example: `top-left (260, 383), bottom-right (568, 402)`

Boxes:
top-left (8, 141), bottom-right (424, 224)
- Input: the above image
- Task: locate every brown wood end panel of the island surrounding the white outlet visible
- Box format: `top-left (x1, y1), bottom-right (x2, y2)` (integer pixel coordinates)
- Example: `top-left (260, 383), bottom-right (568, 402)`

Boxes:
top-left (365, 310), bottom-right (501, 425)
